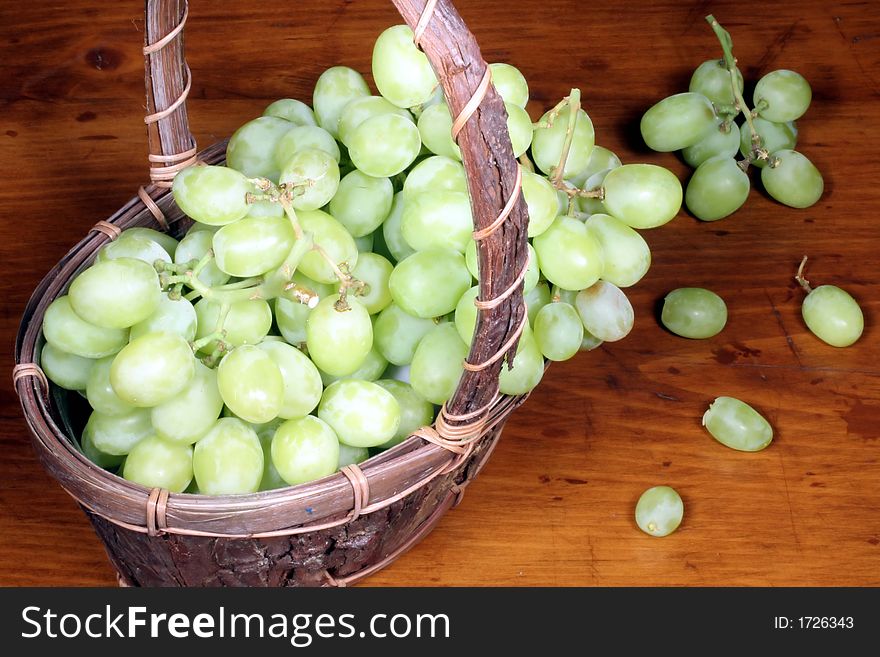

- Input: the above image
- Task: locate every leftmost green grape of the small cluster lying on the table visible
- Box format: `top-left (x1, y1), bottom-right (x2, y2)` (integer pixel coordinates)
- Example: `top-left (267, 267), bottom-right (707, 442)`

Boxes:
top-left (641, 92), bottom-right (717, 153)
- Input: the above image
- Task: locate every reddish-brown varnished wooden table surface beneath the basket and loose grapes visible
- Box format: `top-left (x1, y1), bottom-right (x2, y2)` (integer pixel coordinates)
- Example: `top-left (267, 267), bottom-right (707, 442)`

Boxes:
top-left (0, 0), bottom-right (880, 586)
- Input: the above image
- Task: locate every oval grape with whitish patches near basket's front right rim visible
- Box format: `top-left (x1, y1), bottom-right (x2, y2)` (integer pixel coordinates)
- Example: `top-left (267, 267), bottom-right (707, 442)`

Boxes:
top-left (318, 379), bottom-right (400, 447)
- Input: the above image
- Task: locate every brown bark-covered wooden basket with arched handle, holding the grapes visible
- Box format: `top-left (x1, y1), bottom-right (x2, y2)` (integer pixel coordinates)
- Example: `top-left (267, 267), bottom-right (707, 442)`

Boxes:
top-left (13, 0), bottom-right (528, 586)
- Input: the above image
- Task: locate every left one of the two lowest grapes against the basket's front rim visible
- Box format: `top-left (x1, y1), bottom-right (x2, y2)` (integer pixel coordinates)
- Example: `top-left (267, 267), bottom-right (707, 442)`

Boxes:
top-left (122, 436), bottom-right (193, 493)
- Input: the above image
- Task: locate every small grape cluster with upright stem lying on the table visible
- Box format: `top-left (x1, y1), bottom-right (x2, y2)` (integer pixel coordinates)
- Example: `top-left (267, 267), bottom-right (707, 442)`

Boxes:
top-left (641, 16), bottom-right (824, 221)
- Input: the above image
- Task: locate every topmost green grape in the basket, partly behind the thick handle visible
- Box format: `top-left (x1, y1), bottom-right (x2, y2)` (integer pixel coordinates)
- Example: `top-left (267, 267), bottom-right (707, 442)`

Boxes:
top-left (373, 25), bottom-right (439, 107)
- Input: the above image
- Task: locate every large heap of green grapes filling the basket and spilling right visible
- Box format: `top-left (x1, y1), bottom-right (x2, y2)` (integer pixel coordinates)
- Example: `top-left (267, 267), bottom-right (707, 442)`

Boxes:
top-left (41, 25), bottom-right (682, 494)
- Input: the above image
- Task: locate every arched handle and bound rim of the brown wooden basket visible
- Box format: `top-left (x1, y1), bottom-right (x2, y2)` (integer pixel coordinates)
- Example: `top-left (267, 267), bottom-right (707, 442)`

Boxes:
top-left (13, 0), bottom-right (528, 540)
